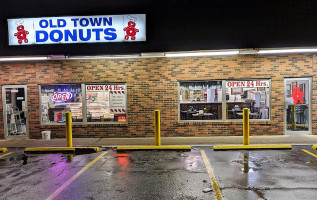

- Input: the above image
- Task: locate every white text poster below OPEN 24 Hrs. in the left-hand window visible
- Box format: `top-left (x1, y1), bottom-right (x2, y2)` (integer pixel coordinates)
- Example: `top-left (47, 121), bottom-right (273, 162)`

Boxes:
top-left (110, 90), bottom-right (126, 114)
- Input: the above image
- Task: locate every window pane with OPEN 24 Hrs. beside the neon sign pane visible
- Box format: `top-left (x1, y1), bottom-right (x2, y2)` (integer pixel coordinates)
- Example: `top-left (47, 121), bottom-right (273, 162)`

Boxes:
top-left (85, 84), bottom-right (127, 122)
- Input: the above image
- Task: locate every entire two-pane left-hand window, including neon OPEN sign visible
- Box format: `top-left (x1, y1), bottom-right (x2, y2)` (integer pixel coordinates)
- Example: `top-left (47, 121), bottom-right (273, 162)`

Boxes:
top-left (40, 83), bottom-right (127, 124)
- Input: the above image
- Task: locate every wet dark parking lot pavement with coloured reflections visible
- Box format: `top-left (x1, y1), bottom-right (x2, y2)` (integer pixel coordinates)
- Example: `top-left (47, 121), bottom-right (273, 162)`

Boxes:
top-left (0, 145), bottom-right (317, 200)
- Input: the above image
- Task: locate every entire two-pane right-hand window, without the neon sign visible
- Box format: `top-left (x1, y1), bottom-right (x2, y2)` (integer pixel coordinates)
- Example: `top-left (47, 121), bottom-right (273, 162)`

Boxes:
top-left (179, 79), bottom-right (270, 121)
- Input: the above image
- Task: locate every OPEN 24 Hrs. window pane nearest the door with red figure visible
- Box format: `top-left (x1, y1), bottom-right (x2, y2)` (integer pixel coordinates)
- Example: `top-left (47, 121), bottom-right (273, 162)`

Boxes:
top-left (226, 80), bottom-right (270, 119)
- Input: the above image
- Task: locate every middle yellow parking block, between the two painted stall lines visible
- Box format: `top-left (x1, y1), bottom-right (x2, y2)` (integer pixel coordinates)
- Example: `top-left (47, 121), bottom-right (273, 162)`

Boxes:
top-left (117, 146), bottom-right (191, 151)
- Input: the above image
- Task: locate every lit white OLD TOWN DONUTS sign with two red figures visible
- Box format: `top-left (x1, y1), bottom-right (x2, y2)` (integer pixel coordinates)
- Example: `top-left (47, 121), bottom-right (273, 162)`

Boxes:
top-left (8, 14), bottom-right (146, 46)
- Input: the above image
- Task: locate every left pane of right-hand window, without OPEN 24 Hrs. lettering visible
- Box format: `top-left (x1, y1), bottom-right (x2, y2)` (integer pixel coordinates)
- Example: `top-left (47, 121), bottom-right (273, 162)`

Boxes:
top-left (179, 81), bottom-right (222, 120)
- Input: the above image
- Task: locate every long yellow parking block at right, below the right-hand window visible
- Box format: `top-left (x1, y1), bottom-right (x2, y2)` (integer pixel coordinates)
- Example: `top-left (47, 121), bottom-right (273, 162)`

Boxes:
top-left (213, 144), bottom-right (292, 151)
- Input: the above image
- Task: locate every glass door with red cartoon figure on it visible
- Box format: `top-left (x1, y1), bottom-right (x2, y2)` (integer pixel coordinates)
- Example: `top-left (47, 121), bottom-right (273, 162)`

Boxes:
top-left (284, 78), bottom-right (311, 135)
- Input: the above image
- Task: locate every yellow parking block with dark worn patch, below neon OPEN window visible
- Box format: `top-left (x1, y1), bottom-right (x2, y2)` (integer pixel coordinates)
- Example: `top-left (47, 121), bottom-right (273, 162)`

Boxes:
top-left (24, 147), bottom-right (99, 154)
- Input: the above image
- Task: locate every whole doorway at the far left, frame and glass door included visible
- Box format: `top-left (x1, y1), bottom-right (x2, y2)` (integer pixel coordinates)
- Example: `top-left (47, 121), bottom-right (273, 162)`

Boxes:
top-left (2, 85), bottom-right (29, 138)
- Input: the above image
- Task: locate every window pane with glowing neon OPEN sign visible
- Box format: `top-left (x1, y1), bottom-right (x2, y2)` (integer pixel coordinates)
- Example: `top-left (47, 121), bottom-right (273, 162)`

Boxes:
top-left (40, 84), bottom-right (83, 124)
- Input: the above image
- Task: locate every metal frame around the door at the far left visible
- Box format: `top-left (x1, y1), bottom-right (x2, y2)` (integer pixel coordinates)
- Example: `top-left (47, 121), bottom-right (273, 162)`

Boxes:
top-left (2, 85), bottom-right (29, 139)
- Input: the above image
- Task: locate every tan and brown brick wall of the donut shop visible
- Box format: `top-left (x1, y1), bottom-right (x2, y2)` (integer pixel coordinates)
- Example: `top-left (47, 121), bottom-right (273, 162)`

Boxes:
top-left (0, 54), bottom-right (317, 138)
